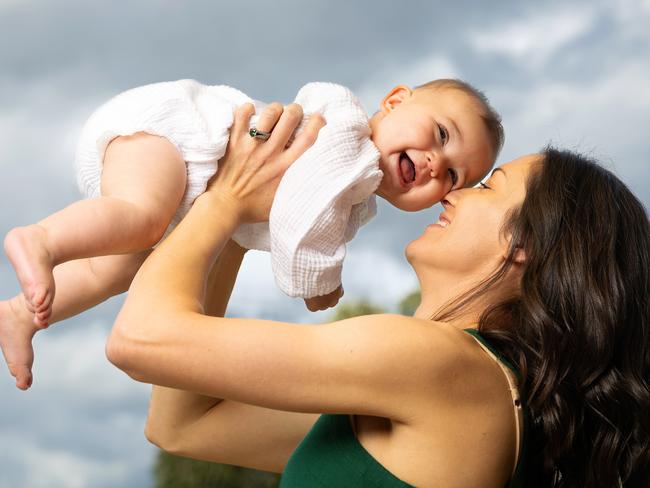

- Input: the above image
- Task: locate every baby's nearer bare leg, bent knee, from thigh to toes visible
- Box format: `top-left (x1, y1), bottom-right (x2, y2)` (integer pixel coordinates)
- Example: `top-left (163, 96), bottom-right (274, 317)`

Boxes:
top-left (5, 133), bottom-right (186, 315)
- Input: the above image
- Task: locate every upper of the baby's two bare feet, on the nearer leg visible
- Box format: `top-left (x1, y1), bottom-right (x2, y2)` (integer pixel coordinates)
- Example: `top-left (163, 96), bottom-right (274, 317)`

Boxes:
top-left (5, 225), bottom-right (54, 316)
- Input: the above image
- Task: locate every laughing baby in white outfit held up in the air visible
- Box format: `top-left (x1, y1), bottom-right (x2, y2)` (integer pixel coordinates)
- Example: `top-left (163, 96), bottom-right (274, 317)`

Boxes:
top-left (0, 80), bottom-right (503, 389)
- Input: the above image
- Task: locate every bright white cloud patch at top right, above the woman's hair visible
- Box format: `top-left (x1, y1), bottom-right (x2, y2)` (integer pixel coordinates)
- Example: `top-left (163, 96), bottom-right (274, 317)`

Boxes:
top-left (469, 6), bottom-right (596, 68)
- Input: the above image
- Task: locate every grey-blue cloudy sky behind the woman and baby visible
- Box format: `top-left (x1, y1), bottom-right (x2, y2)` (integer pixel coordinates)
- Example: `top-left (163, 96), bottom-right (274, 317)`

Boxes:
top-left (0, 0), bottom-right (650, 488)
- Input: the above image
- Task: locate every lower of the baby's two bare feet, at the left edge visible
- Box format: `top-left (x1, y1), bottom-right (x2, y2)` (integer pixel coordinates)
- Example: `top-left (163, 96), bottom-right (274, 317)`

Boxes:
top-left (0, 295), bottom-right (39, 390)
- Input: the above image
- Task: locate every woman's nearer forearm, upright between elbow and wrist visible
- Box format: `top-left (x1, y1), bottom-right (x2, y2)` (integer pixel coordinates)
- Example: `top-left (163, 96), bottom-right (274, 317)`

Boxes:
top-left (106, 189), bottom-right (239, 380)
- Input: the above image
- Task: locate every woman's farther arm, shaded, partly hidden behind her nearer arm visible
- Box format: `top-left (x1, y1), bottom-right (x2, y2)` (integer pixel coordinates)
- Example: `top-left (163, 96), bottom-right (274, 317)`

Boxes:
top-left (145, 240), bottom-right (318, 473)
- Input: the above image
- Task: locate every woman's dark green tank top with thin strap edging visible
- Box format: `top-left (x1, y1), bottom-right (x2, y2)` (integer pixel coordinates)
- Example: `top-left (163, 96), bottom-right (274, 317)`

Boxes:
top-left (280, 329), bottom-right (527, 488)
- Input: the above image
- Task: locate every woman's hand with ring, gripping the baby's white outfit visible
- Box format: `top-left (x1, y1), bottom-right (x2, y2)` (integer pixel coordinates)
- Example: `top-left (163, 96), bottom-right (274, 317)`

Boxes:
top-left (205, 103), bottom-right (325, 223)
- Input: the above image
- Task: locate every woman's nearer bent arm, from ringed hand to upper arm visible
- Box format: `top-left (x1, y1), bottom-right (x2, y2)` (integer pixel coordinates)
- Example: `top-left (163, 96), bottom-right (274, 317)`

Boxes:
top-left (107, 101), bottom-right (471, 432)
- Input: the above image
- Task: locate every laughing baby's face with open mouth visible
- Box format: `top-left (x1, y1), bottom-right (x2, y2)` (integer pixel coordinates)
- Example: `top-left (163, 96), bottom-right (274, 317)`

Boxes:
top-left (370, 87), bottom-right (494, 211)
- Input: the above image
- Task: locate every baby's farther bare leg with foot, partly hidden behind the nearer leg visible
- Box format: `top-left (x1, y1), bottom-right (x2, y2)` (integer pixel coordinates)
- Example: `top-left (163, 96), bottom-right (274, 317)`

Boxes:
top-left (0, 250), bottom-right (150, 390)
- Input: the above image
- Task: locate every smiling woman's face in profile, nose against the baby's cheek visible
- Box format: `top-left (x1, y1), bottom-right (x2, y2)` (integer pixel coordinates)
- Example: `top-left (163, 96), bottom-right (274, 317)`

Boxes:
top-left (406, 155), bottom-right (541, 281)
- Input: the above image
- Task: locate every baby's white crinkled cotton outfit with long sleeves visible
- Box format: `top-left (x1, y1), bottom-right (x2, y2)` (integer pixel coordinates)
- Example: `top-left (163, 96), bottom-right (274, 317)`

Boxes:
top-left (75, 80), bottom-right (383, 298)
